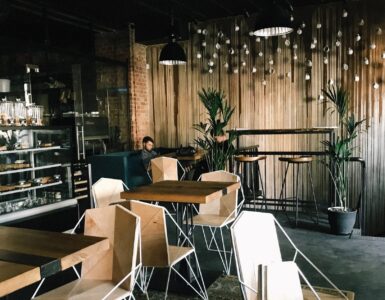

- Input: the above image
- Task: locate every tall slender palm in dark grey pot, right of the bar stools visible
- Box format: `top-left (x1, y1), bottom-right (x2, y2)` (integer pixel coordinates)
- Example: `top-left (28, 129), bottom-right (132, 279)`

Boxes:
top-left (322, 85), bottom-right (365, 234)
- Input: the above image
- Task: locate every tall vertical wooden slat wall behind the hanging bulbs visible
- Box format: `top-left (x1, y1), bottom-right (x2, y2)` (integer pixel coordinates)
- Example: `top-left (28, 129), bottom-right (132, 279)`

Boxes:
top-left (148, 1), bottom-right (385, 234)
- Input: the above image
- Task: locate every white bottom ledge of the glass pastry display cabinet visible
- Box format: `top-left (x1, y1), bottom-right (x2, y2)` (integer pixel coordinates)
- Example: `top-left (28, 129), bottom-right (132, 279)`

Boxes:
top-left (0, 199), bottom-right (78, 224)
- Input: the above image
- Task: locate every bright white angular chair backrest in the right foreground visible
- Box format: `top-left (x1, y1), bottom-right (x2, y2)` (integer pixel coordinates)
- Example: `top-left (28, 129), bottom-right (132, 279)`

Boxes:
top-left (231, 211), bottom-right (282, 300)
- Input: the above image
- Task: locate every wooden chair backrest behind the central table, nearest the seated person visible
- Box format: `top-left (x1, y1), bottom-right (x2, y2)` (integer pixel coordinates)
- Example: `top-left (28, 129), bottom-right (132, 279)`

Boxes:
top-left (151, 156), bottom-right (179, 183)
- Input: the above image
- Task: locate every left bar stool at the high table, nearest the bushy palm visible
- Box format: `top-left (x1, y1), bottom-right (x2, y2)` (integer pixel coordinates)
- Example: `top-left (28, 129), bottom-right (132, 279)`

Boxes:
top-left (234, 155), bottom-right (267, 210)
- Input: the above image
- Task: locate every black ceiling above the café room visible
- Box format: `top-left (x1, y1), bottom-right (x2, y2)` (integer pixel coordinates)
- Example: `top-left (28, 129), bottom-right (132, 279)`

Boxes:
top-left (0, 0), bottom-right (342, 42)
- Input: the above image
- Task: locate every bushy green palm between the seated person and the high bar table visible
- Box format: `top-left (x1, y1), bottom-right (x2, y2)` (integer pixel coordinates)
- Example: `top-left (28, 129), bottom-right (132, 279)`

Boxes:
top-left (193, 89), bottom-right (236, 171)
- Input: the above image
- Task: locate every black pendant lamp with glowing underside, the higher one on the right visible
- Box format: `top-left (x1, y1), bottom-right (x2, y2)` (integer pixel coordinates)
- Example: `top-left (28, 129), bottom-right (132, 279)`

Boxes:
top-left (254, 0), bottom-right (293, 37)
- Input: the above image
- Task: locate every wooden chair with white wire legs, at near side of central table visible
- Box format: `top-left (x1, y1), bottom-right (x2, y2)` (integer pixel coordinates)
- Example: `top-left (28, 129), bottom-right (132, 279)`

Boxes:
top-left (121, 200), bottom-right (208, 299)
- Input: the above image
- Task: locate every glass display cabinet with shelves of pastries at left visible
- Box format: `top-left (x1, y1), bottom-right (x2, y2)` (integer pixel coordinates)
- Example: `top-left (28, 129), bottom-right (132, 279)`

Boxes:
top-left (0, 126), bottom-right (77, 224)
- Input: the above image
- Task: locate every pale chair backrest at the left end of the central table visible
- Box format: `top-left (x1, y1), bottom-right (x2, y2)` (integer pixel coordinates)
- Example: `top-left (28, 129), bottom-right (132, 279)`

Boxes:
top-left (92, 177), bottom-right (124, 207)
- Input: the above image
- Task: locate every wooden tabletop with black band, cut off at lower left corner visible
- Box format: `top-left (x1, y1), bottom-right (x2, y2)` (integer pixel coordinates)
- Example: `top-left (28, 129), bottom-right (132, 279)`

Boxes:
top-left (0, 226), bottom-right (109, 297)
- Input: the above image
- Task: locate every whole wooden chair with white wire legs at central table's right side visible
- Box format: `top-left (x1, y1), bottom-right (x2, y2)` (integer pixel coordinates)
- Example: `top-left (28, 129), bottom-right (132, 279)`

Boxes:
top-left (193, 171), bottom-right (244, 275)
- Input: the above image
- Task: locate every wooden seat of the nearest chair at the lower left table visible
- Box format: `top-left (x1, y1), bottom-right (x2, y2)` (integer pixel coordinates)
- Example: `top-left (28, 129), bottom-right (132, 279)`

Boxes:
top-left (35, 279), bottom-right (131, 300)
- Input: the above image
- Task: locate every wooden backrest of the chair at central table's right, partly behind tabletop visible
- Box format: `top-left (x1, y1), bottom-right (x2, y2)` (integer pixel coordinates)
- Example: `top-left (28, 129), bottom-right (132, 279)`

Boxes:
top-left (199, 171), bottom-right (240, 218)
